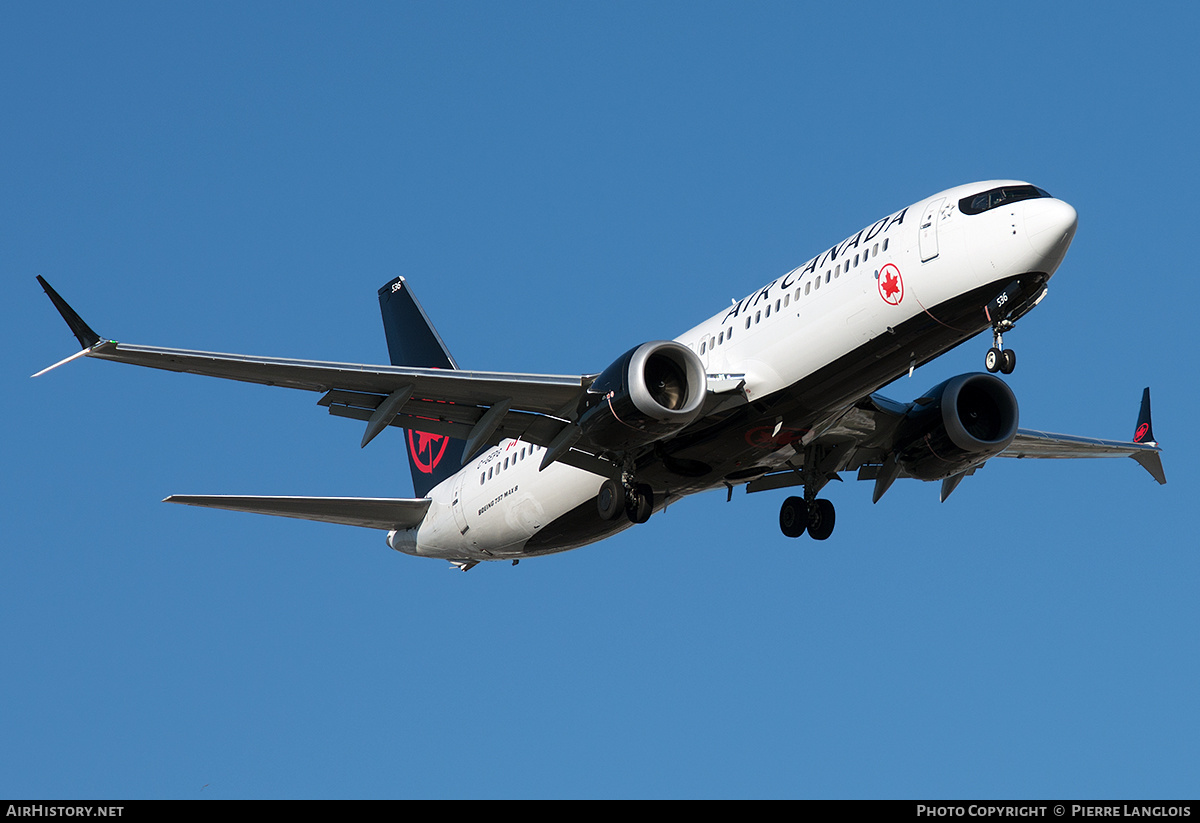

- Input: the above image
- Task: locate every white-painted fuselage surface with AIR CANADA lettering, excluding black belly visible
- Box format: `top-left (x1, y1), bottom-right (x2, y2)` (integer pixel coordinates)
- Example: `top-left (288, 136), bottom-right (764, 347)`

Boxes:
top-left (388, 181), bottom-right (1075, 560)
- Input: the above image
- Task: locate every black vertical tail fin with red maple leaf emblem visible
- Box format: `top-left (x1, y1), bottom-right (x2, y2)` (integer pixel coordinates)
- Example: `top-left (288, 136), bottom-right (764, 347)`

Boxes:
top-left (379, 277), bottom-right (464, 497)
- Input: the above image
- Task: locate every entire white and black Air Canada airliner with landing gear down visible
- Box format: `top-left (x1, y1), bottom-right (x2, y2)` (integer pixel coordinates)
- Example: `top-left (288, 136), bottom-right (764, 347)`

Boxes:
top-left (35, 180), bottom-right (1166, 571)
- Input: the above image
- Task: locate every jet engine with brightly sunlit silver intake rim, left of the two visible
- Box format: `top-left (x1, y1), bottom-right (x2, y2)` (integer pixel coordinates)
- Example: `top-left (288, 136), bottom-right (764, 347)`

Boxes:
top-left (578, 340), bottom-right (708, 451)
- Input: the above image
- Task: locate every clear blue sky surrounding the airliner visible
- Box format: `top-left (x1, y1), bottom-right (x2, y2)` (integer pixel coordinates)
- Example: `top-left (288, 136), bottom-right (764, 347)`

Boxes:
top-left (0, 2), bottom-right (1200, 798)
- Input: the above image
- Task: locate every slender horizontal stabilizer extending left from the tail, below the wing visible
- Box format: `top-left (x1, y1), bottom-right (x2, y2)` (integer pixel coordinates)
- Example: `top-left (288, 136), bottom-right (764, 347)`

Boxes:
top-left (163, 494), bottom-right (430, 531)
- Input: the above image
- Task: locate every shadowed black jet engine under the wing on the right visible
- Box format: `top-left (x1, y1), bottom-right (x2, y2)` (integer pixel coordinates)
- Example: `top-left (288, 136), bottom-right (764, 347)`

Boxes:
top-left (896, 373), bottom-right (1018, 480)
